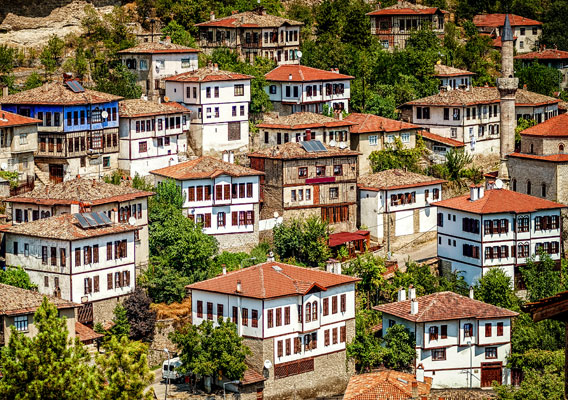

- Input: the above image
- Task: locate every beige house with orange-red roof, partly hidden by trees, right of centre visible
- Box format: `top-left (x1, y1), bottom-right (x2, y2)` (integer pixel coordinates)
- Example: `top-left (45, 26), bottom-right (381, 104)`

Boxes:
top-left (345, 113), bottom-right (420, 175)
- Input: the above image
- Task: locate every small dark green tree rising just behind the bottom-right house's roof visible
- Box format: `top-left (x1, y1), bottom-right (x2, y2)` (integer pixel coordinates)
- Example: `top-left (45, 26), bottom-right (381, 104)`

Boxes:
top-left (474, 267), bottom-right (519, 310)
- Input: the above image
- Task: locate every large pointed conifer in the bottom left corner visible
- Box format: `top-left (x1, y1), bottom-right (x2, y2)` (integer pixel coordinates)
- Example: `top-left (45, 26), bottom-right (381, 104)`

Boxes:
top-left (0, 298), bottom-right (98, 400)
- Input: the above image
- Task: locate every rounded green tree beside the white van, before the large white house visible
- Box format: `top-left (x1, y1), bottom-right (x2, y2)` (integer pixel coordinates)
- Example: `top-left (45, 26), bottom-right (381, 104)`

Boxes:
top-left (170, 318), bottom-right (251, 380)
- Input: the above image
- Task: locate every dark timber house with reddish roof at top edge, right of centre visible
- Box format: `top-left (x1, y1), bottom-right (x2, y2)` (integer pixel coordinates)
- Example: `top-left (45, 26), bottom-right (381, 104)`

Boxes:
top-left (367, 0), bottom-right (448, 49)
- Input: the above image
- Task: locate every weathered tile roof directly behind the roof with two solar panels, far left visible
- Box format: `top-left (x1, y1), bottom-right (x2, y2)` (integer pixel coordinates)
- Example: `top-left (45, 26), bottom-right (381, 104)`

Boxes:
top-left (6, 178), bottom-right (154, 205)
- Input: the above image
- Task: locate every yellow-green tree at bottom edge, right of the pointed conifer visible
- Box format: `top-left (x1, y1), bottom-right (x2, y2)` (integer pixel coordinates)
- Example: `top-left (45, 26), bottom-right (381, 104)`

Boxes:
top-left (95, 336), bottom-right (154, 400)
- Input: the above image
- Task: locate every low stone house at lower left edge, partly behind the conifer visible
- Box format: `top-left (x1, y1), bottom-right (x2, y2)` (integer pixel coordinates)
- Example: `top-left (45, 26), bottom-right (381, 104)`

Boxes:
top-left (0, 283), bottom-right (79, 349)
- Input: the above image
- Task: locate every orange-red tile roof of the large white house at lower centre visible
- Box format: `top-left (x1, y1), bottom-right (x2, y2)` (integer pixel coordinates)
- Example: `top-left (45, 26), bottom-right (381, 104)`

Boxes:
top-left (187, 261), bottom-right (360, 299)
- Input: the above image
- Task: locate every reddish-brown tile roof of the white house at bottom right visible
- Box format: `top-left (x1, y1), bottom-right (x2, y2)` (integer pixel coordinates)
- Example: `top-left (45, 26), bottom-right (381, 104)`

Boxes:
top-left (373, 292), bottom-right (518, 322)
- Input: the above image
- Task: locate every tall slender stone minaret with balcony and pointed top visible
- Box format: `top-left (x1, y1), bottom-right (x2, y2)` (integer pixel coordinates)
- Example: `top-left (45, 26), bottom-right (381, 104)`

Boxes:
top-left (497, 14), bottom-right (519, 187)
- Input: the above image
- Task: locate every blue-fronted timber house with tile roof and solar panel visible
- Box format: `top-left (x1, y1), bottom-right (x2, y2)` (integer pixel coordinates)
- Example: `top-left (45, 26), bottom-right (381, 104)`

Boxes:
top-left (0, 76), bottom-right (122, 183)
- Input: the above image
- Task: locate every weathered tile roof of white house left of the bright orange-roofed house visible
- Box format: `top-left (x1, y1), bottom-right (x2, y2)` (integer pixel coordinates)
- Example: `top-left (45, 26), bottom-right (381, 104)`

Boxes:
top-left (357, 169), bottom-right (446, 190)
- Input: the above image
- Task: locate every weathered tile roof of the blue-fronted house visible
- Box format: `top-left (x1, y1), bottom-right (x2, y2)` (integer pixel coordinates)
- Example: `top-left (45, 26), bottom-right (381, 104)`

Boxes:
top-left (0, 82), bottom-right (122, 105)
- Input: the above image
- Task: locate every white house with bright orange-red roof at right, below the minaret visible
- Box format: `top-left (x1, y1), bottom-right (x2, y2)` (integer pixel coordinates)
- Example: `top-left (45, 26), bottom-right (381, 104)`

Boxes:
top-left (433, 185), bottom-right (565, 289)
